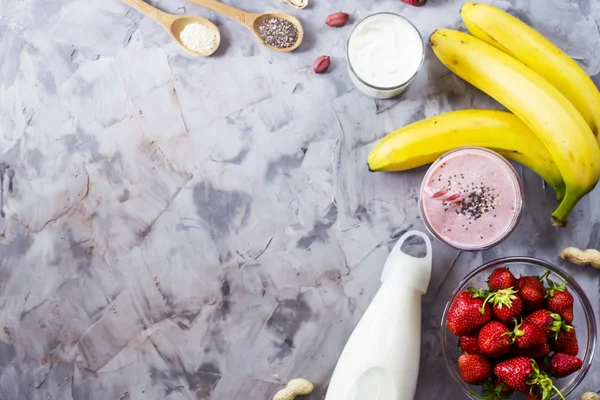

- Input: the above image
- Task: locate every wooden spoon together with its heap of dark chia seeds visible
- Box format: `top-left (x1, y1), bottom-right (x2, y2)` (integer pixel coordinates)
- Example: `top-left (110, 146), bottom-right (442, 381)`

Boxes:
top-left (188, 0), bottom-right (304, 52)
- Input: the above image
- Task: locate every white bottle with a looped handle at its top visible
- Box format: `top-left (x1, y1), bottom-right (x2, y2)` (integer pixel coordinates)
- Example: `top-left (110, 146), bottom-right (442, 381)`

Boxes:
top-left (325, 231), bottom-right (431, 400)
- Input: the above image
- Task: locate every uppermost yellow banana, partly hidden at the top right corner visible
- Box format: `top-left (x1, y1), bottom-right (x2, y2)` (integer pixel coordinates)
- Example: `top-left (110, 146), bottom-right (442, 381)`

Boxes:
top-left (460, 2), bottom-right (600, 142)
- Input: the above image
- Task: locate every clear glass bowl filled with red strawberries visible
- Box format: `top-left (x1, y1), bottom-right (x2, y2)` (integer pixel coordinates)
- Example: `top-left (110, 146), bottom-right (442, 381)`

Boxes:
top-left (441, 257), bottom-right (596, 400)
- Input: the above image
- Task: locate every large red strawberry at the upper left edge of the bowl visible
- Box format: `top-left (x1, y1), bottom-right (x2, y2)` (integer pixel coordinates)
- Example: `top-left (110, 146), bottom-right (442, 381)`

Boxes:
top-left (446, 289), bottom-right (492, 336)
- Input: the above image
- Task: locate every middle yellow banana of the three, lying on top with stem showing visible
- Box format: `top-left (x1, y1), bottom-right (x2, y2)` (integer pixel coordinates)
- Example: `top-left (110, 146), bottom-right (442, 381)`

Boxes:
top-left (429, 29), bottom-right (600, 226)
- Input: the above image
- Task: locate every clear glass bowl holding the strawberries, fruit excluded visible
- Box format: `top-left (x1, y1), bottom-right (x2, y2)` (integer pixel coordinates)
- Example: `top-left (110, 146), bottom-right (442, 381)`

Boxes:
top-left (441, 257), bottom-right (596, 400)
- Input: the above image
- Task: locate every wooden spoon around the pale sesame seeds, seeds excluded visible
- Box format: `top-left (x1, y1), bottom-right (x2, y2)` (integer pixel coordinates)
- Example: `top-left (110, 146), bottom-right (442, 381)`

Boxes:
top-left (121, 0), bottom-right (221, 57)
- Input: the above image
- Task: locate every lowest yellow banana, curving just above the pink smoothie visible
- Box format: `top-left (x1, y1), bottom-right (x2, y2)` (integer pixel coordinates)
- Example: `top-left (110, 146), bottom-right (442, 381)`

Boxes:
top-left (368, 110), bottom-right (565, 200)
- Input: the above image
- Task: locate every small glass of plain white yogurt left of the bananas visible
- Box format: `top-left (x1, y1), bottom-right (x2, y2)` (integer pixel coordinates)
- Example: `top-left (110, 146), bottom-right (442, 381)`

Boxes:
top-left (347, 12), bottom-right (425, 99)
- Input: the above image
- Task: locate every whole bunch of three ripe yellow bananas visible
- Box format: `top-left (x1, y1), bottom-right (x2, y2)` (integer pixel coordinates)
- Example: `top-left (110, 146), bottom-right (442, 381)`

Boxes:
top-left (369, 3), bottom-right (600, 226)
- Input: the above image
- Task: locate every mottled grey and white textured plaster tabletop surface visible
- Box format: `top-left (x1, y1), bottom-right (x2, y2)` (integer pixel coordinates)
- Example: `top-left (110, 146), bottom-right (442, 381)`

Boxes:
top-left (0, 0), bottom-right (600, 400)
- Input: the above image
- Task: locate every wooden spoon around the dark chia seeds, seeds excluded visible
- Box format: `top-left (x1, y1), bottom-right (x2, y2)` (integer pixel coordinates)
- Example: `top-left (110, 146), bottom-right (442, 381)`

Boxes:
top-left (188, 0), bottom-right (304, 52)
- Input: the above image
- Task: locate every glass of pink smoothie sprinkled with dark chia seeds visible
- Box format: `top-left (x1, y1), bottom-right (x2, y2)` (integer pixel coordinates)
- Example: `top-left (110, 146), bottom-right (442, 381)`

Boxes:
top-left (419, 147), bottom-right (523, 251)
